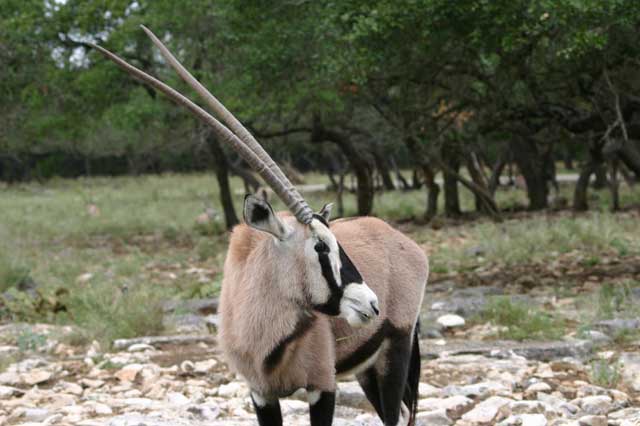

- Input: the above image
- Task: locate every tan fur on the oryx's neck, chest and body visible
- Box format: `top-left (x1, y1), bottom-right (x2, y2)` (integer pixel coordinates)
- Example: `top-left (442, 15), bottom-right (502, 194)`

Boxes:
top-left (220, 214), bottom-right (428, 395)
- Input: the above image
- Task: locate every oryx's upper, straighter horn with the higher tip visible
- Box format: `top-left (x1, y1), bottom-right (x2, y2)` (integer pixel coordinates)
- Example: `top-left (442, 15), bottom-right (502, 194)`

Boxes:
top-left (140, 25), bottom-right (313, 223)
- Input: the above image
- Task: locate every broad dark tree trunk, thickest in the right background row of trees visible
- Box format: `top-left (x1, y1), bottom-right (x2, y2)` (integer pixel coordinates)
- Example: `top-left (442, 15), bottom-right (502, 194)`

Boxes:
top-left (513, 136), bottom-right (548, 210)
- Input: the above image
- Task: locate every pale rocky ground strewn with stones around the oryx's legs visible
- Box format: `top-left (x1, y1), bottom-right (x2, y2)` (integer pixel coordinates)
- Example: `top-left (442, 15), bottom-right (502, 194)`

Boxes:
top-left (0, 283), bottom-right (640, 426)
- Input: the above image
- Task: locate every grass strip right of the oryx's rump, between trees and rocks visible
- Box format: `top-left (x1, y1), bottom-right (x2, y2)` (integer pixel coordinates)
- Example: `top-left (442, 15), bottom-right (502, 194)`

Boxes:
top-left (415, 212), bottom-right (640, 272)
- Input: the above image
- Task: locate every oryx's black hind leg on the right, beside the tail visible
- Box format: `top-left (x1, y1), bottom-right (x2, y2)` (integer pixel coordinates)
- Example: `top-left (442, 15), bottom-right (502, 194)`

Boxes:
top-left (374, 332), bottom-right (412, 426)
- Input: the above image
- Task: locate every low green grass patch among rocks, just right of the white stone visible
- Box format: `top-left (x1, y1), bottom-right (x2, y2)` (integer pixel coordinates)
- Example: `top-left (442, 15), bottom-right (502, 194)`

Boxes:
top-left (477, 296), bottom-right (564, 340)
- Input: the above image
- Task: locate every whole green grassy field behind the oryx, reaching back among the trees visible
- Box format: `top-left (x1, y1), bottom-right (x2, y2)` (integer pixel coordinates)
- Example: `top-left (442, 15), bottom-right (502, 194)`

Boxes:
top-left (0, 175), bottom-right (640, 342)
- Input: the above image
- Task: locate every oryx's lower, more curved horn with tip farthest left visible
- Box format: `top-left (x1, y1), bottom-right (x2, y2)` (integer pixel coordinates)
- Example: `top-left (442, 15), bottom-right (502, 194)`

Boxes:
top-left (90, 44), bottom-right (313, 223)
